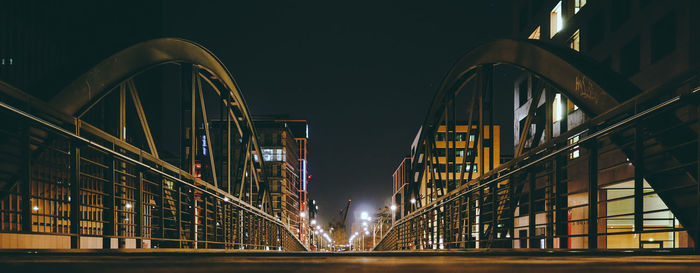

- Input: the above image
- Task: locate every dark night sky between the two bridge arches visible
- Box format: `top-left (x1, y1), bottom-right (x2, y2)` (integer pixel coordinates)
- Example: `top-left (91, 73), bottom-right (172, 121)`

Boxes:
top-left (165, 0), bottom-right (512, 224)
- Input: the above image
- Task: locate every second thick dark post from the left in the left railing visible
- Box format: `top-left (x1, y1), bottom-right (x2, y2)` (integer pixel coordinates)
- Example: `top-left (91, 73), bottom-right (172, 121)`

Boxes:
top-left (70, 142), bottom-right (81, 248)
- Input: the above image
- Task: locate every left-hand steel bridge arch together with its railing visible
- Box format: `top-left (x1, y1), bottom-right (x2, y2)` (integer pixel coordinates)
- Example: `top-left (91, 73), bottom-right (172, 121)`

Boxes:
top-left (0, 38), bottom-right (306, 251)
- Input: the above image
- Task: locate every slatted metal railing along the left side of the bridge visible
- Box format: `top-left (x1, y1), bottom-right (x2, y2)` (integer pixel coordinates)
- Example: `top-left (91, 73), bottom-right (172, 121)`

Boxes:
top-left (0, 86), bottom-right (307, 251)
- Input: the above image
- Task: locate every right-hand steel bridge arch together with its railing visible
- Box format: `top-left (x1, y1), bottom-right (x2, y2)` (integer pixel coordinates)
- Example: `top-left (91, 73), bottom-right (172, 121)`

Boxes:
top-left (375, 40), bottom-right (700, 250)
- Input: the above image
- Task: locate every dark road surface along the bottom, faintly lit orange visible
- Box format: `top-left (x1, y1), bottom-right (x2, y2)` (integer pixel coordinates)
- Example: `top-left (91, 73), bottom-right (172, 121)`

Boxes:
top-left (0, 252), bottom-right (700, 273)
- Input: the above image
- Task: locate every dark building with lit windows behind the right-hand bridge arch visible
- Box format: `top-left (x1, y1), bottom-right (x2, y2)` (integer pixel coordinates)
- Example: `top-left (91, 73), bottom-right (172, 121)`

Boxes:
top-left (513, 0), bottom-right (700, 248)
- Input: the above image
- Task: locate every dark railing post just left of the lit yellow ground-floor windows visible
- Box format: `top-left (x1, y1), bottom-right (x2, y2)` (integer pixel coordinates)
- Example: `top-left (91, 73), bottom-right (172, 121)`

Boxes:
top-left (588, 139), bottom-right (598, 249)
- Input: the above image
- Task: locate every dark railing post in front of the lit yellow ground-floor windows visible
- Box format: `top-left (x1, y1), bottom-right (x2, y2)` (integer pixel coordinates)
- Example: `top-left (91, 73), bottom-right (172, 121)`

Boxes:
top-left (634, 125), bottom-right (644, 248)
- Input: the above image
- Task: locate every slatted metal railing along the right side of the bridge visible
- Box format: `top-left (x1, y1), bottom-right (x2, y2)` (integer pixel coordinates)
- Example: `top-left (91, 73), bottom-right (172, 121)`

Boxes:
top-left (374, 88), bottom-right (700, 251)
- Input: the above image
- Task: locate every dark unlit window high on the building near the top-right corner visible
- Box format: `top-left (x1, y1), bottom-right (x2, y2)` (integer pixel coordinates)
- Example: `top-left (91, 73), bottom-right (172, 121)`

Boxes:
top-left (651, 13), bottom-right (676, 63)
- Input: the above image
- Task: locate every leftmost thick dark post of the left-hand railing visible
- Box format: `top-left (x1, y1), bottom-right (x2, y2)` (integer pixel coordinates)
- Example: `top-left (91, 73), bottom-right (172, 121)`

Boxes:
top-left (19, 121), bottom-right (31, 233)
